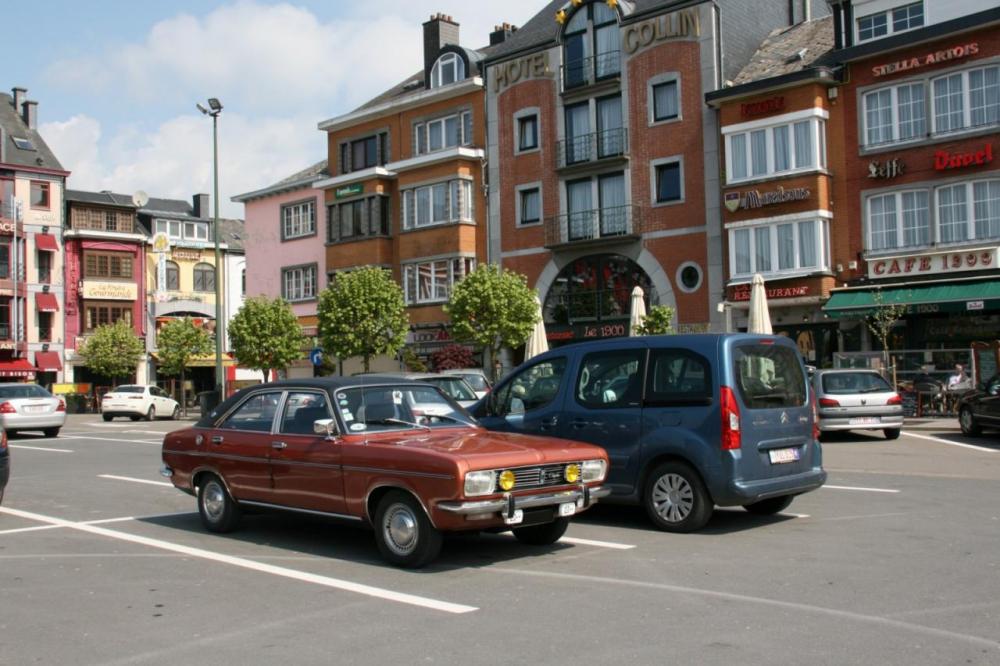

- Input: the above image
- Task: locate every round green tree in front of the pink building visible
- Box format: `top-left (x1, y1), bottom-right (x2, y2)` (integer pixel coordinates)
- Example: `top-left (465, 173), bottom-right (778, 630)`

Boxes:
top-left (229, 296), bottom-right (303, 382)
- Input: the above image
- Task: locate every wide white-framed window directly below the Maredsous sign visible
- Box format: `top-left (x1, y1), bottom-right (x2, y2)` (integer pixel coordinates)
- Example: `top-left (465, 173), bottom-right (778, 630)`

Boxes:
top-left (729, 220), bottom-right (830, 278)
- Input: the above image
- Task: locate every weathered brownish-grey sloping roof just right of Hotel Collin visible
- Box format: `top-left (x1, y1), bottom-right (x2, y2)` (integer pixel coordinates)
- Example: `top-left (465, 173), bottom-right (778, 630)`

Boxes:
top-left (733, 15), bottom-right (833, 86)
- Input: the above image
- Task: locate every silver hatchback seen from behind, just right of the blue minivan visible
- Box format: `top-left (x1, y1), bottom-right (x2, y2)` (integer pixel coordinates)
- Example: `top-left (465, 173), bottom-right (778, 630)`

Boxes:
top-left (813, 369), bottom-right (903, 439)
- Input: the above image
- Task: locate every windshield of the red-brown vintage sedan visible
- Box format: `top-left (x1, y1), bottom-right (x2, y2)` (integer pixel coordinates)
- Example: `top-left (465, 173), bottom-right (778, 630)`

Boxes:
top-left (335, 384), bottom-right (475, 434)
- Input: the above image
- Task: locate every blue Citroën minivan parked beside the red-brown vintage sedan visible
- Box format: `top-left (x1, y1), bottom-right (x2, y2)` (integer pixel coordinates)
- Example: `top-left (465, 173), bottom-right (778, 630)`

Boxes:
top-left (471, 333), bottom-right (826, 532)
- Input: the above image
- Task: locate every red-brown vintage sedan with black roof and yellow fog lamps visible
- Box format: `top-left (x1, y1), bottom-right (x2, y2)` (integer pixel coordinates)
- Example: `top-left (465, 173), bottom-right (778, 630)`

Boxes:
top-left (161, 376), bottom-right (610, 567)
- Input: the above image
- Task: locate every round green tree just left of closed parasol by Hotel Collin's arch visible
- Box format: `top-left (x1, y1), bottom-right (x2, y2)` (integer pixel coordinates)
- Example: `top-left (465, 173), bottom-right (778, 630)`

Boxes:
top-left (444, 265), bottom-right (538, 359)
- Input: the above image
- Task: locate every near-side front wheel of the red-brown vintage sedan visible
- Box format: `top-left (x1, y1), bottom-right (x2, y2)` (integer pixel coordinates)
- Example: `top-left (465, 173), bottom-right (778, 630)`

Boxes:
top-left (375, 491), bottom-right (441, 569)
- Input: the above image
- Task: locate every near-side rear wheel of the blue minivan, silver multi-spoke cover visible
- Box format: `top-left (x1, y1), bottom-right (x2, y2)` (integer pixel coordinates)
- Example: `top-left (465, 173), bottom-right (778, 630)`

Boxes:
top-left (643, 462), bottom-right (714, 532)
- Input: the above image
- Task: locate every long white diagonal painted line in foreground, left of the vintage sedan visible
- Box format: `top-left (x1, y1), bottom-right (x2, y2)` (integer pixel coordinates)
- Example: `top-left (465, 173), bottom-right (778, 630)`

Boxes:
top-left (0, 507), bottom-right (479, 613)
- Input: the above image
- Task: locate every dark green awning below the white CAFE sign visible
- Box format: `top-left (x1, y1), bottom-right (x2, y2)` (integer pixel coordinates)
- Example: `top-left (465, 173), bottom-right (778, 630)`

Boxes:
top-left (823, 279), bottom-right (1000, 319)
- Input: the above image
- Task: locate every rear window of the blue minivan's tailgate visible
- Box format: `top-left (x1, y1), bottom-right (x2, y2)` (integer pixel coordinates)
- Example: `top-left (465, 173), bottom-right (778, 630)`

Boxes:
top-left (733, 344), bottom-right (806, 409)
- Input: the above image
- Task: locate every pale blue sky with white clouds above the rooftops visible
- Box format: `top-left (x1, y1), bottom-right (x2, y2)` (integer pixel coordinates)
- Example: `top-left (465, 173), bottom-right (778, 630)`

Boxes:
top-left (7, 0), bottom-right (546, 217)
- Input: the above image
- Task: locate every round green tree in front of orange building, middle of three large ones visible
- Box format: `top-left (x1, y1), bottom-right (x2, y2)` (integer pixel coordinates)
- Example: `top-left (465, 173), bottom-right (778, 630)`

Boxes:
top-left (316, 266), bottom-right (410, 372)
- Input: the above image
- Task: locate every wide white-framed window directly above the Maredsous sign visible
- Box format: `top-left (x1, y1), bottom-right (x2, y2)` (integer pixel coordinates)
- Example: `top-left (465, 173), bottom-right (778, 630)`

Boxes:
top-left (723, 111), bottom-right (826, 183)
